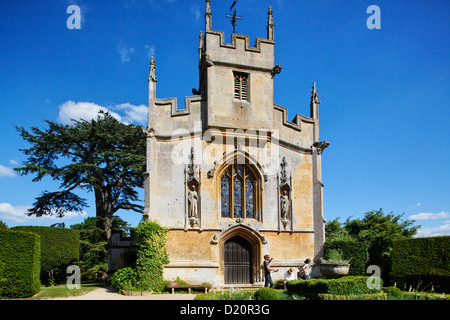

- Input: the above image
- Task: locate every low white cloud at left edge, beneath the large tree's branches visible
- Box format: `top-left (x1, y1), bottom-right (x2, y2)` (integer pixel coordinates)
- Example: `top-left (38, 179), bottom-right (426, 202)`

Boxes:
top-left (0, 202), bottom-right (87, 224)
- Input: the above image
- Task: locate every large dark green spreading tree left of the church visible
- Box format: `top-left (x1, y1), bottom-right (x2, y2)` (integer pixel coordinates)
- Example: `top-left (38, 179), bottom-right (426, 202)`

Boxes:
top-left (15, 113), bottom-right (145, 239)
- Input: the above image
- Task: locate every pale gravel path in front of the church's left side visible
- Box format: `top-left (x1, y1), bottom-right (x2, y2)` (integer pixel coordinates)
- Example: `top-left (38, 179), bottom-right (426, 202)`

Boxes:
top-left (51, 287), bottom-right (195, 300)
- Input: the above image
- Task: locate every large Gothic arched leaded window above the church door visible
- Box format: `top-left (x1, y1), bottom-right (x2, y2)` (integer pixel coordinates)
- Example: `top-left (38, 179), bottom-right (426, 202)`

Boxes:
top-left (220, 164), bottom-right (257, 219)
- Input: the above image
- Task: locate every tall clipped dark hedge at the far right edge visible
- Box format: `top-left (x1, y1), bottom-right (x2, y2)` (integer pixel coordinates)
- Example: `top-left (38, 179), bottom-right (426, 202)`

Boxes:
top-left (390, 236), bottom-right (450, 292)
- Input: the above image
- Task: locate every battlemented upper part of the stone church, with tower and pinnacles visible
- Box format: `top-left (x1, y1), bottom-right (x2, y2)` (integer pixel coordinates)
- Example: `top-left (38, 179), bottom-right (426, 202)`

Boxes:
top-left (149, 0), bottom-right (320, 148)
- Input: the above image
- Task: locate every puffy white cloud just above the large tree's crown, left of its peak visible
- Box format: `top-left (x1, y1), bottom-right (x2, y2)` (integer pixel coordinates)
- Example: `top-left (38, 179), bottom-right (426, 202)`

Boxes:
top-left (58, 100), bottom-right (122, 124)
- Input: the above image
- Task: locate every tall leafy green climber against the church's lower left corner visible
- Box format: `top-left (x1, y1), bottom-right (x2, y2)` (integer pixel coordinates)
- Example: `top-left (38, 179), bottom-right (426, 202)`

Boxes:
top-left (136, 221), bottom-right (169, 292)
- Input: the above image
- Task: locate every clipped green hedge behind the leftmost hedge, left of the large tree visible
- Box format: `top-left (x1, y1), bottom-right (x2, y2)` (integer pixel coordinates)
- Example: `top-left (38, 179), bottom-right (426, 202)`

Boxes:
top-left (10, 226), bottom-right (80, 281)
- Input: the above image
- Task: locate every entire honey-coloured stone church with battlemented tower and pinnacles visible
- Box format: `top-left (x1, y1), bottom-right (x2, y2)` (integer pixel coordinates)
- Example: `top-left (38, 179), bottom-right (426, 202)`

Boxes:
top-left (144, 0), bottom-right (328, 286)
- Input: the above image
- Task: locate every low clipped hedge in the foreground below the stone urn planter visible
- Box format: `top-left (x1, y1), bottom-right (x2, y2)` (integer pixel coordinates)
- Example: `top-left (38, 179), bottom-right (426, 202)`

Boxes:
top-left (286, 276), bottom-right (382, 296)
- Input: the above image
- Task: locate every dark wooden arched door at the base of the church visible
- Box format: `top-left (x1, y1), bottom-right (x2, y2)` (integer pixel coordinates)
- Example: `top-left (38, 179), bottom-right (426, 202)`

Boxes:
top-left (223, 236), bottom-right (253, 284)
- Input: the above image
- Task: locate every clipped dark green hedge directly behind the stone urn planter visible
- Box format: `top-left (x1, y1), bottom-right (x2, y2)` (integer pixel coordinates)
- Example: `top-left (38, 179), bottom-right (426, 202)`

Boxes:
top-left (324, 240), bottom-right (369, 276)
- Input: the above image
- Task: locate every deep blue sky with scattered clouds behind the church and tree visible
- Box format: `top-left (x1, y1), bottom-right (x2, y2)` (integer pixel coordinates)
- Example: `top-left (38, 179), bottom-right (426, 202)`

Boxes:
top-left (0, 0), bottom-right (450, 236)
